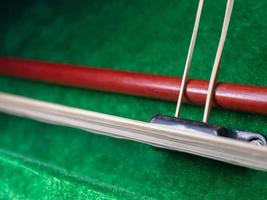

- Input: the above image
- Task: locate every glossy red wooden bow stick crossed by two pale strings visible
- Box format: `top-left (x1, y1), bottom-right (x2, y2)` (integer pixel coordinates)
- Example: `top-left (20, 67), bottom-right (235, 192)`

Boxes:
top-left (0, 58), bottom-right (267, 114)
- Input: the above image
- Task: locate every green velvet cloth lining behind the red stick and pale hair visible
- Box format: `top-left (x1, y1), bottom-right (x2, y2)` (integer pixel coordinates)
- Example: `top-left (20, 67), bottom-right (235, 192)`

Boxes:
top-left (0, 0), bottom-right (267, 200)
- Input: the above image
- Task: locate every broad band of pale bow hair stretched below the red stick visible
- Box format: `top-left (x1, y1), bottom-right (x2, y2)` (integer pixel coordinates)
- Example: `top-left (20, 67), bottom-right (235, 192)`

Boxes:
top-left (0, 93), bottom-right (267, 171)
